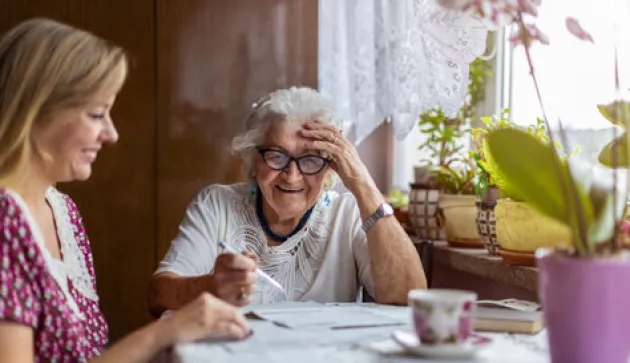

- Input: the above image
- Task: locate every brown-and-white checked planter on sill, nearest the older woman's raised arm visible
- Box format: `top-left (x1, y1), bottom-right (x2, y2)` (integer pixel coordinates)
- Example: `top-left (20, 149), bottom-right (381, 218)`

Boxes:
top-left (409, 184), bottom-right (445, 241)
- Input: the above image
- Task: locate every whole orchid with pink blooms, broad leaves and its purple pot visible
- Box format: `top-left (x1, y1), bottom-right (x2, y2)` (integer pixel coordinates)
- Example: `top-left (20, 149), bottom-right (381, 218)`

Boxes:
top-left (440, 0), bottom-right (630, 363)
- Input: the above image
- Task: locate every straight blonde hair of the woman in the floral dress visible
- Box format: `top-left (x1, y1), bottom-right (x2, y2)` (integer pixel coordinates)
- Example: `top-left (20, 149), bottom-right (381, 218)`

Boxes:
top-left (0, 19), bottom-right (127, 182)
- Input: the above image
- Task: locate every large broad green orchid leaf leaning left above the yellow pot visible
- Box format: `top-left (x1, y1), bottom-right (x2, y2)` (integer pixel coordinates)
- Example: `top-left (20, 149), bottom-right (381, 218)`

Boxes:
top-left (487, 129), bottom-right (568, 223)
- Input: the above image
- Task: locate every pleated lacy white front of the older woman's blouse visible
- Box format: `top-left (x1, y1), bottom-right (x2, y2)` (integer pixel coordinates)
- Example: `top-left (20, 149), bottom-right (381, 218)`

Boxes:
top-left (225, 188), bottom-right (332, 303)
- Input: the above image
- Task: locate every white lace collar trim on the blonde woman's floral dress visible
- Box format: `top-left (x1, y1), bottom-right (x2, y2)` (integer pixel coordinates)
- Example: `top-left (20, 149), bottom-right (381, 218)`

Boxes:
top-left (46, 188), bottom-right (98, 301)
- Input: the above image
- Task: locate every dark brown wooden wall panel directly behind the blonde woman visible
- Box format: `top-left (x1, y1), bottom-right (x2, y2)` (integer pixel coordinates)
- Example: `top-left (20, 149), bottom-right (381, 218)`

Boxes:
top-left (0, 0), bottom-right (156, 340)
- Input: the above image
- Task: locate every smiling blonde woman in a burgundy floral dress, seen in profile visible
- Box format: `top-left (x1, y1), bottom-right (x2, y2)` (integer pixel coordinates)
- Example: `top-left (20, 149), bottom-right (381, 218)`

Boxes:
top-left (0, 19), bottom-right (255, 363)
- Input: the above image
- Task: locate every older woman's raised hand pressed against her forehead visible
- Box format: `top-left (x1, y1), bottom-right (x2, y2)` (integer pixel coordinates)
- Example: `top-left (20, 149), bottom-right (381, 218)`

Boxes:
top-left (300, 121), bottom-right (373, 191)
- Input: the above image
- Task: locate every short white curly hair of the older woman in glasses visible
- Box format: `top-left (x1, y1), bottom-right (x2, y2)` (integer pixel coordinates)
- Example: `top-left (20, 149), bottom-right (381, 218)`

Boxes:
top-left (231, 87), bottom-right (343, 189)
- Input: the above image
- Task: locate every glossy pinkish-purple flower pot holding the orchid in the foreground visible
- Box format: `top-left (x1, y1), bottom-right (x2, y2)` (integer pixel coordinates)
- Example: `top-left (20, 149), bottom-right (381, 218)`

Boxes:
top-left (537, 250), bottom-right (630, 363)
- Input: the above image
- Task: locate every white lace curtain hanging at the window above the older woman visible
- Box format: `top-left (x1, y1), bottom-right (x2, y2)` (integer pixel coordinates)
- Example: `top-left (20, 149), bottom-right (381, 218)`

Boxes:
top-left (318, 0), bottom-right (488, 144)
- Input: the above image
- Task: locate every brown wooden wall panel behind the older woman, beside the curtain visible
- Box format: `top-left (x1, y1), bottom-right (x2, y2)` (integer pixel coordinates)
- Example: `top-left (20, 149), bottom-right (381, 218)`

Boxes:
top-left (157, 0), bottom-right (317, 257)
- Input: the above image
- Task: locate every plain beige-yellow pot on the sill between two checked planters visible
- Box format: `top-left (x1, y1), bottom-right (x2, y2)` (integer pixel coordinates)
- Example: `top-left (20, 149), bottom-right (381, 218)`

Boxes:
top-left (438, 194), bottom-right (483, 248)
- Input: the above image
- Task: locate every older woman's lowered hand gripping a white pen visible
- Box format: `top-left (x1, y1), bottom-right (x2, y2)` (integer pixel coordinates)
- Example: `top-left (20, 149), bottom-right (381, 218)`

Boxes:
top-left (210, 251), bottom-right (257, 306)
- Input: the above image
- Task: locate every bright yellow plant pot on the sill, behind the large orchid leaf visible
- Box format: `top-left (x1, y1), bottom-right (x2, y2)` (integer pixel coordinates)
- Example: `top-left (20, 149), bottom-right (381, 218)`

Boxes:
top-left (494, 199), bottom-right (571, 253)
